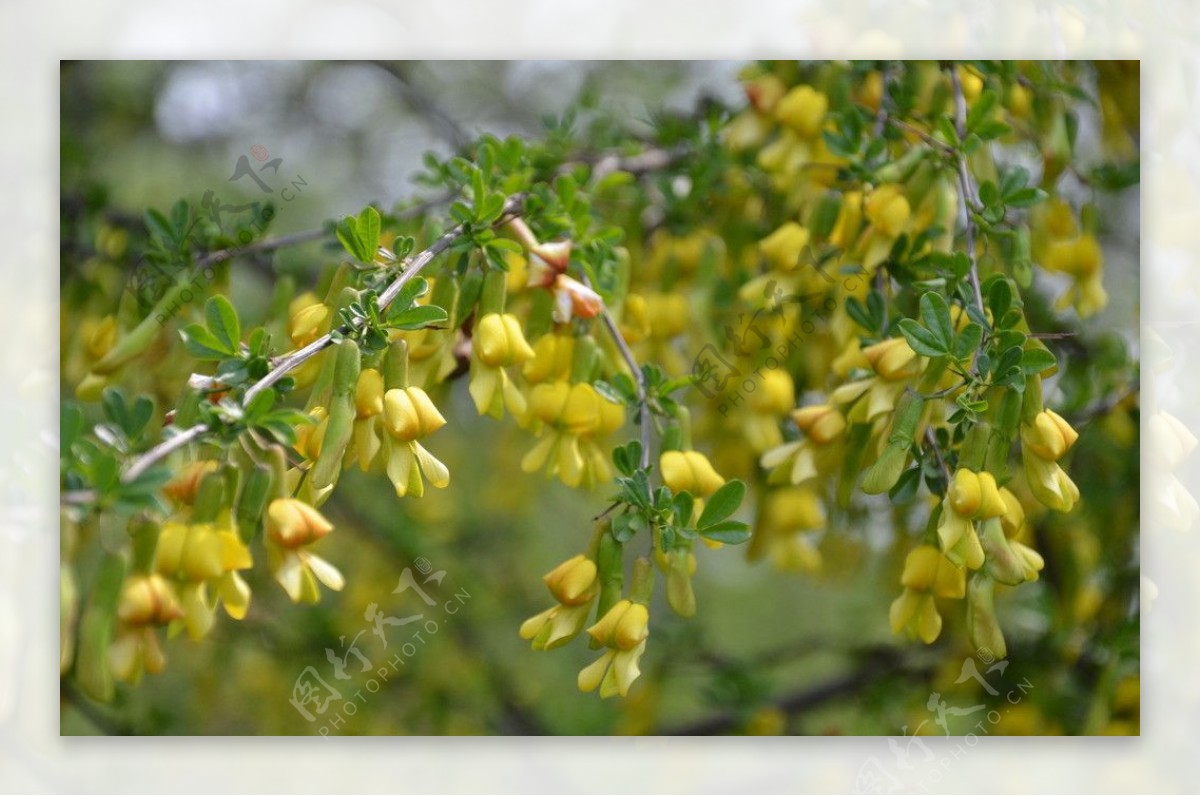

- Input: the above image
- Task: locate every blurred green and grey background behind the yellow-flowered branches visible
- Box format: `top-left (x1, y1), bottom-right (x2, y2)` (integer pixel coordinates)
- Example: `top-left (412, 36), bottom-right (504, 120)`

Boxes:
top-left (61, 62), bottom-right (1138, 735)
